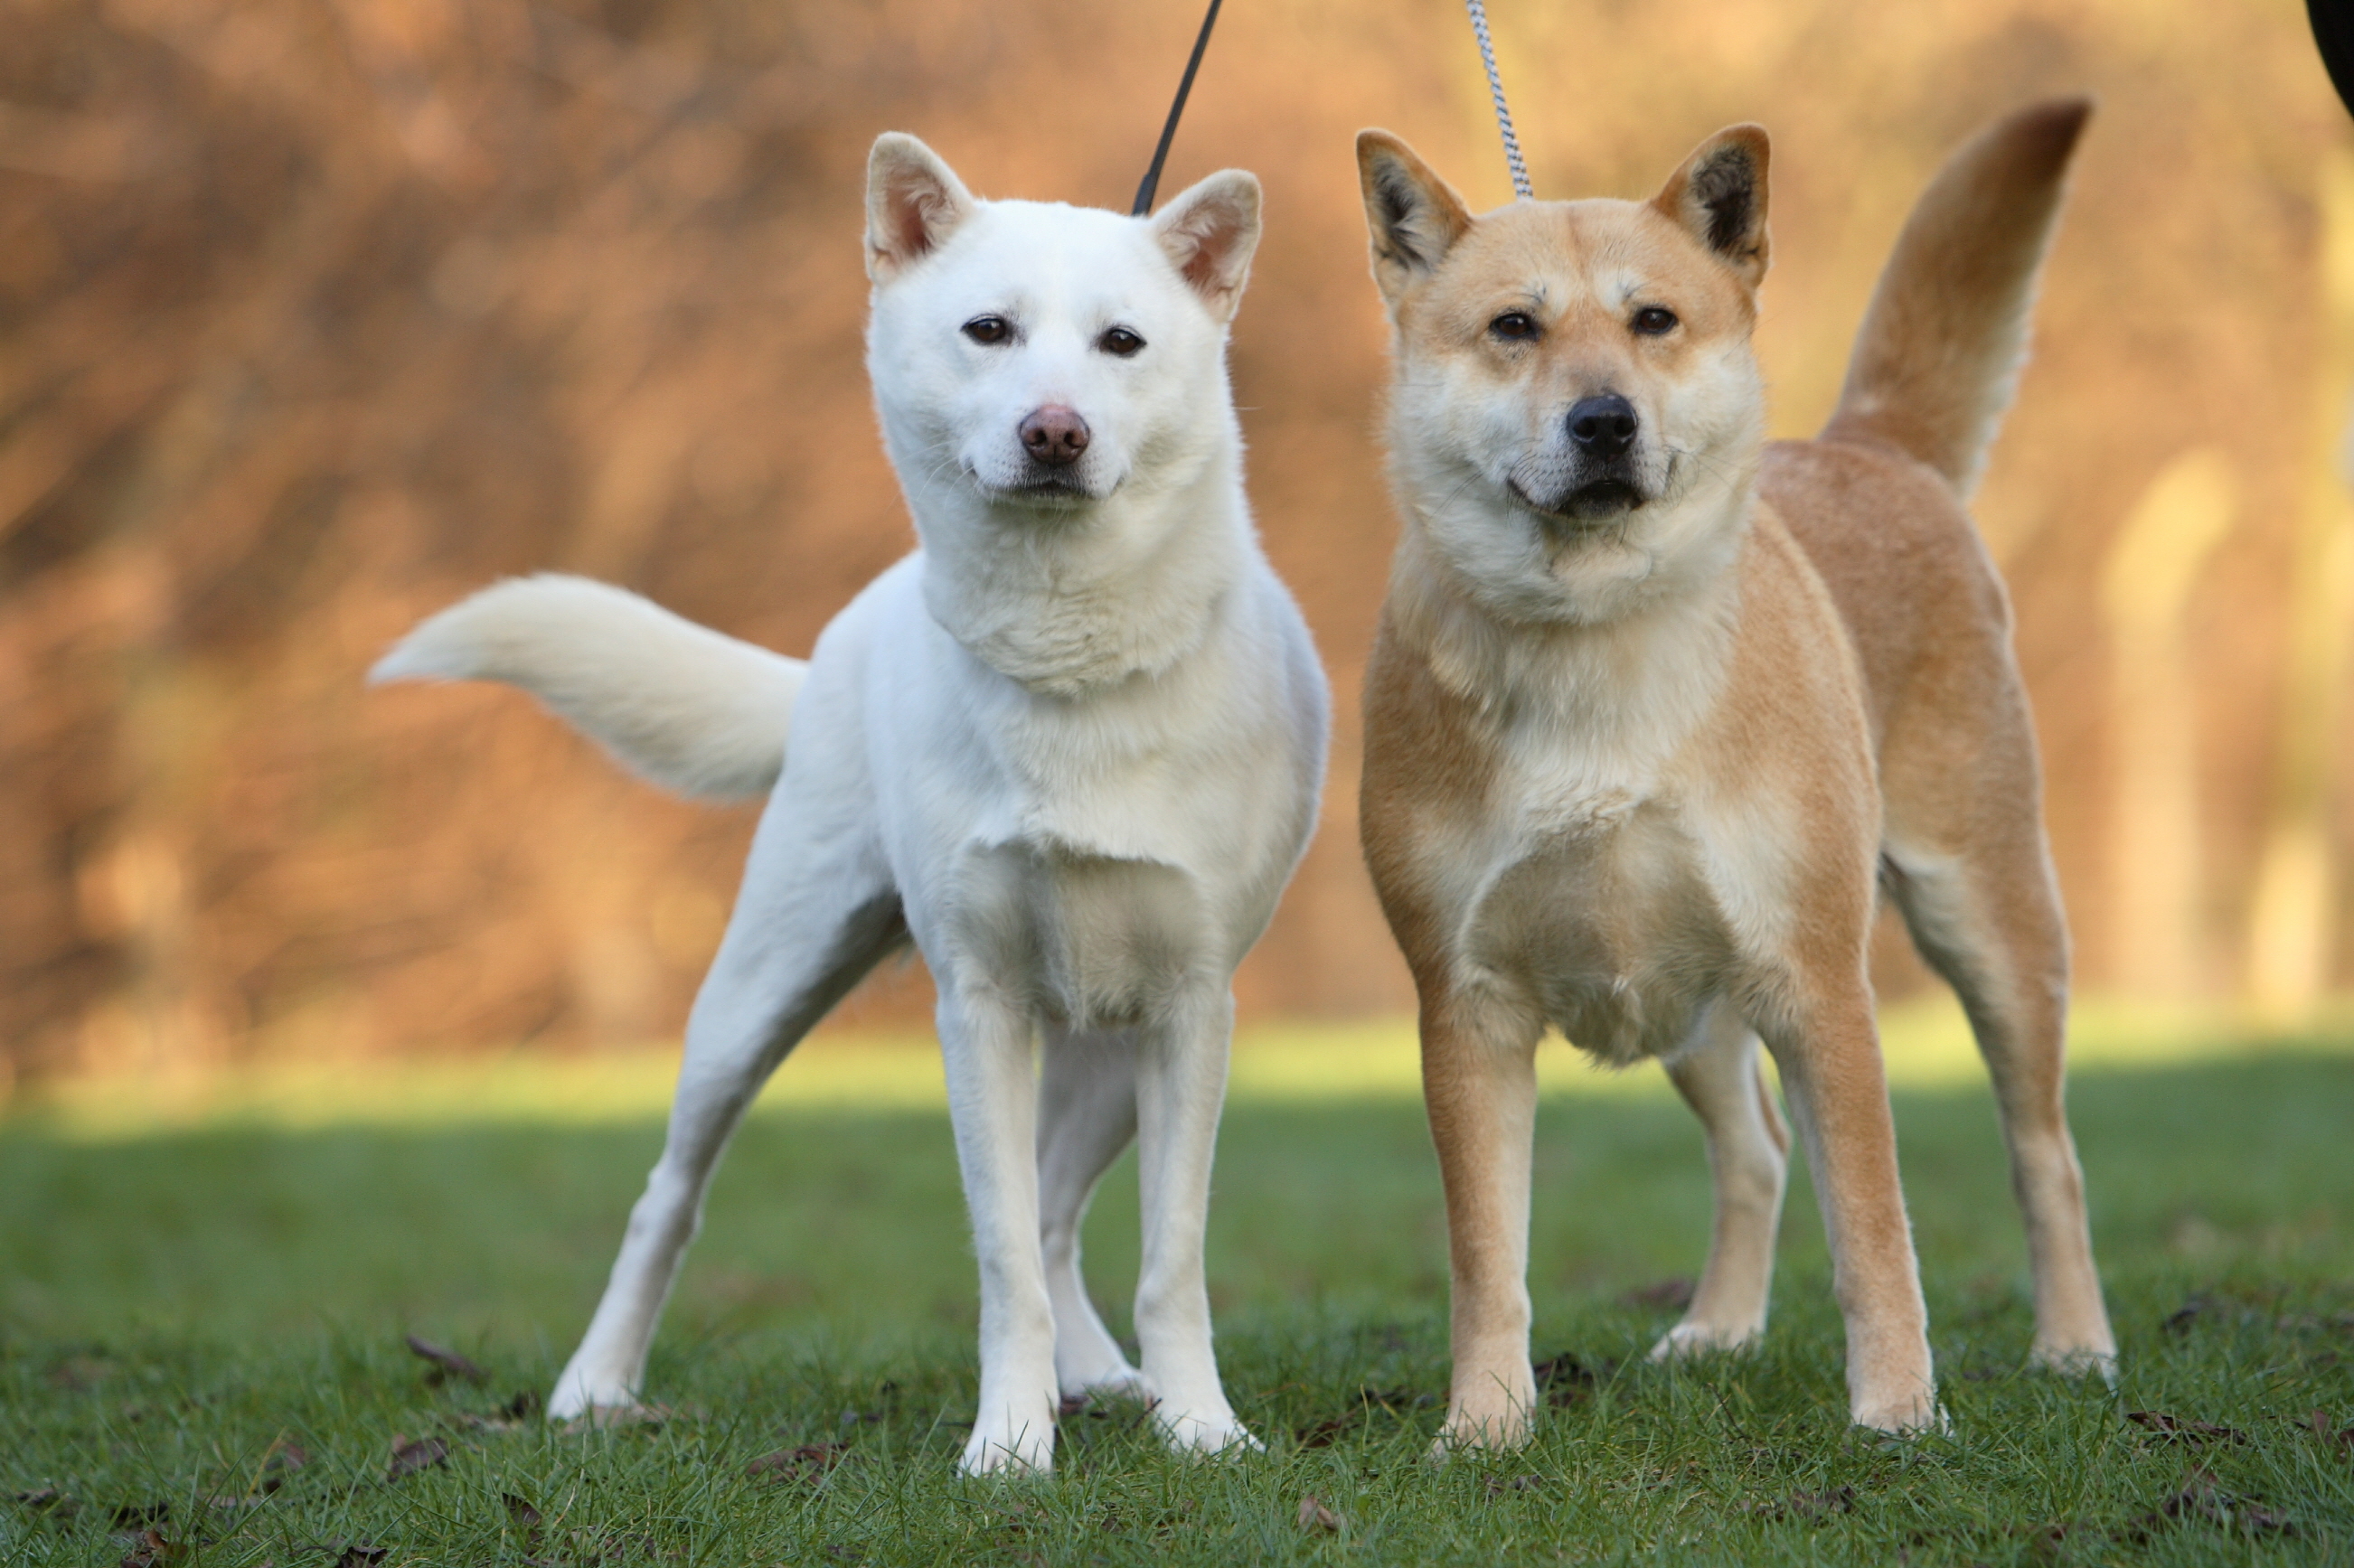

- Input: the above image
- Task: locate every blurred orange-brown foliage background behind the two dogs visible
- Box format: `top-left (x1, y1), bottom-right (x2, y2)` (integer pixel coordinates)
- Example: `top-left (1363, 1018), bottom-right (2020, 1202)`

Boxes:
top-left (0, 0), bottom-right (2354, 1083)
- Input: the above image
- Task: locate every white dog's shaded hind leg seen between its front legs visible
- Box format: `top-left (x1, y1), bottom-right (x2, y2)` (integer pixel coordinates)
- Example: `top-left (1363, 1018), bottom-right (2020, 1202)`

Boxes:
top-left (1038, 1027), bottom-right (1146, 1398)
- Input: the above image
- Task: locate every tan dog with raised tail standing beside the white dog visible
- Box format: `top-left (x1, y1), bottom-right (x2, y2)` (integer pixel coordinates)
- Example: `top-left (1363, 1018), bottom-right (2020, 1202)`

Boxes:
top-left (1359, 101), bottom-right (2116, 1443)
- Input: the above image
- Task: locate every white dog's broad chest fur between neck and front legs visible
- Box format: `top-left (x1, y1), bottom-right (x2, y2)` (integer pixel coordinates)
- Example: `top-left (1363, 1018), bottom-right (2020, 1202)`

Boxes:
top-left (871, 558), bottom-right (1321, 1028)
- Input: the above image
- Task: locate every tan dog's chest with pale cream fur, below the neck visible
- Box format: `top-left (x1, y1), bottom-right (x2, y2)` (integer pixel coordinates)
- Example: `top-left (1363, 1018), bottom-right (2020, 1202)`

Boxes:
top-left (1363, 509), bottom-right (1874, 1066)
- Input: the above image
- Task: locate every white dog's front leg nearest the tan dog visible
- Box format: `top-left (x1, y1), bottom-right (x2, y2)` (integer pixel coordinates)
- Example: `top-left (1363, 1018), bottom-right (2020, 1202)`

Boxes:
top-left (1137, 993), bottom-right (1259, 1452)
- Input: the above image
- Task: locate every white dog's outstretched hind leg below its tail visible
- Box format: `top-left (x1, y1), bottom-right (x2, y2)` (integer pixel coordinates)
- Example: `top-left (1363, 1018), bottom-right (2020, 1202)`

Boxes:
top-left (549, 793), bottom-right (907, 1420)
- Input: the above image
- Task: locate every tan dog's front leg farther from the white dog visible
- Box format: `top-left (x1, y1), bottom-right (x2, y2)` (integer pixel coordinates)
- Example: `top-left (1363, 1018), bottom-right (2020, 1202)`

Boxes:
top-left (1766, 987), bottom-right (1937, 1432)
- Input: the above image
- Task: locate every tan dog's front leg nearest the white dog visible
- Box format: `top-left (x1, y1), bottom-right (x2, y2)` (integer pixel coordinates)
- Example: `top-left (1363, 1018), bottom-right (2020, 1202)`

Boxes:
top-left (1422, 993), bottom-right (1537, 1452)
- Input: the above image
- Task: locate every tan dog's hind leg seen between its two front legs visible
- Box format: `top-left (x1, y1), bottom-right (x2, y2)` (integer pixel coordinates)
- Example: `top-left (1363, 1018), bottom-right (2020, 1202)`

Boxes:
top-left (1650, 1003), bottom-right (1789, 1361)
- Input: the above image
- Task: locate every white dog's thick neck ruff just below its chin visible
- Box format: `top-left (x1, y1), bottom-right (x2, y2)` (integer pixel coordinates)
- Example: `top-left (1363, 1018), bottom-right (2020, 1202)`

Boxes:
top-left (920, 443), bottom-right (1252, 699)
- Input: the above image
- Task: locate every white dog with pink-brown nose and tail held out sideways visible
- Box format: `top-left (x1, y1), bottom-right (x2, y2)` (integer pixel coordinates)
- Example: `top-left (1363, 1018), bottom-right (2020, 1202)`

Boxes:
top-left (374, 134), bottom-right (1330, 1471)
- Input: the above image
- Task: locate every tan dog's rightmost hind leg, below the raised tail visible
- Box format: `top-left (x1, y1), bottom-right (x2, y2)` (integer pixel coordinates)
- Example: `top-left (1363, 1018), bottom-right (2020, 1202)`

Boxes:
top-left (1888, 838), bottom-right (2116, 1377)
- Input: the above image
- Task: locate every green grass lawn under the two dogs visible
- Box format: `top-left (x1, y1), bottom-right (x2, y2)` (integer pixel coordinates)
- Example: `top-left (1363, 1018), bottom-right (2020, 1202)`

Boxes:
top-left (0, 1031), bottom-right (2354, 1568)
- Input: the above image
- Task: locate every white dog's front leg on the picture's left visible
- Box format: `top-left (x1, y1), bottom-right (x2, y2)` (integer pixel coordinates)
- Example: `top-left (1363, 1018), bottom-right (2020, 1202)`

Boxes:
top-left (939, 981), bottom-right (1057, 1474)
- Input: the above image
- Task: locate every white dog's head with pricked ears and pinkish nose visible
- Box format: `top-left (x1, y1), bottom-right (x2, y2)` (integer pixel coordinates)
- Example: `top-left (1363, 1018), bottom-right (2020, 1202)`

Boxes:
top-left (866, 134), bottom-right (1259, 532)
